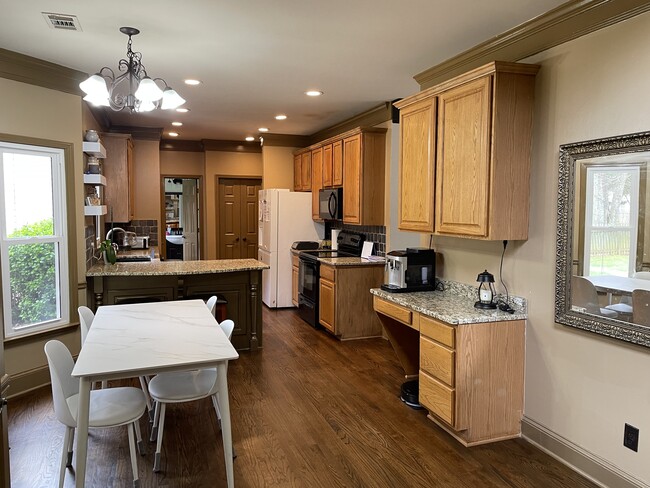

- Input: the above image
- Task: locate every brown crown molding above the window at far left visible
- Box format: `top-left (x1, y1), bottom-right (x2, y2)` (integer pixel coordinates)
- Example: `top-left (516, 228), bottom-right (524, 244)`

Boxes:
top-left (0, 48), bottom-right (88, 95)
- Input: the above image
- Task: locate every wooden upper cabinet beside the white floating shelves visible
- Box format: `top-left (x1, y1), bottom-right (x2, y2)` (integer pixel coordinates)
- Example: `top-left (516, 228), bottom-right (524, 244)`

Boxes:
top-left (102, 133), bottom-right (135, 222)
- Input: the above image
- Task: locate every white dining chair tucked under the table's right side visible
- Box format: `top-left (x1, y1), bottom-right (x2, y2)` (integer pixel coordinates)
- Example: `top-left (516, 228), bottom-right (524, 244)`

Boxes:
top-left (149, 320), bottom-right (235, 472)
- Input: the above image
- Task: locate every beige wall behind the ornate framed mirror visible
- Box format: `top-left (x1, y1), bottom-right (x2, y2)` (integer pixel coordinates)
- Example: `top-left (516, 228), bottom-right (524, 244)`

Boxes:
top-left (410, 14), bottom-right (650, 484)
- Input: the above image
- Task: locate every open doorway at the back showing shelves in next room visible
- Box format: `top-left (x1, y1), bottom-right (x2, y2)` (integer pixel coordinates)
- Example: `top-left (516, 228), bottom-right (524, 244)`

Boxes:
top-left (160, 175), bottom-right (202, 261)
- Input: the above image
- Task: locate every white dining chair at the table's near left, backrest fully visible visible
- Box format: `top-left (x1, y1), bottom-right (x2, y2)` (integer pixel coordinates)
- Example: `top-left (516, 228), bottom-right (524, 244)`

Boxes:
top-left (45, 340), bottom-right (146, 488)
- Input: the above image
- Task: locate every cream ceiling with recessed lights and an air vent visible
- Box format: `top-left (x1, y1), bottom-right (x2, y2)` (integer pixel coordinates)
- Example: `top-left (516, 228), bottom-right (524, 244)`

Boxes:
top-left (0, 0), bottom-right (564, 140)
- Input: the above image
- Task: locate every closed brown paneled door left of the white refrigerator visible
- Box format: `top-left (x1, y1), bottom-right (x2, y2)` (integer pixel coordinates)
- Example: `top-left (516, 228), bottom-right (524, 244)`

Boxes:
top-left (216, 176), bottom-right (262, 259)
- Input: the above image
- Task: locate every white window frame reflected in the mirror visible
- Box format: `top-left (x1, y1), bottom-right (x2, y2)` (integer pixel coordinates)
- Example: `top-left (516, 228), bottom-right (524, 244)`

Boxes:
top-left (584, 165), bottom-right (641, 277)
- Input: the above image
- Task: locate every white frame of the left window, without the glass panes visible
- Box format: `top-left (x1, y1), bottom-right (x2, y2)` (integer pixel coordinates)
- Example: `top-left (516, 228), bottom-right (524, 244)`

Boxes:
top-left (0, 141), bottom-right (70, 338)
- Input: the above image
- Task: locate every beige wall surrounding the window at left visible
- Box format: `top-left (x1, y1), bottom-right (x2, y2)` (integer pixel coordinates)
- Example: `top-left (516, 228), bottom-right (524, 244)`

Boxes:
top-left (0, 78), bottom-right (86, 386)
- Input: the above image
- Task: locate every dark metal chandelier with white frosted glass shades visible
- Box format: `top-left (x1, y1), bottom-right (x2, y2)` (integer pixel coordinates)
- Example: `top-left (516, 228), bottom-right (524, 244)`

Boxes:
top-left (79, 27), bottom-right (185, 113)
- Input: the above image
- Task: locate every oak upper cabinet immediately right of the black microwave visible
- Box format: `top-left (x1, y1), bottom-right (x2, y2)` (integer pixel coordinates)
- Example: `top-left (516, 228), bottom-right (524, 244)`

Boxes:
top-left (343, 129), bottom-right (386, 225)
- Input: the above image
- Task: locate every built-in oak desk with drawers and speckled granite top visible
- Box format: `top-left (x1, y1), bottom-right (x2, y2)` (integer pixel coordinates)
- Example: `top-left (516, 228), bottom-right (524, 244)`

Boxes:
top-left (370, 282), bottom-right (527, 446)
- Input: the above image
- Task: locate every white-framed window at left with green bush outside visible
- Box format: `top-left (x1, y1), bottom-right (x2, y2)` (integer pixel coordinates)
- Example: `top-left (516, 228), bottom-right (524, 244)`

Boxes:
top-left (0, 142), bottom-right (70, 337)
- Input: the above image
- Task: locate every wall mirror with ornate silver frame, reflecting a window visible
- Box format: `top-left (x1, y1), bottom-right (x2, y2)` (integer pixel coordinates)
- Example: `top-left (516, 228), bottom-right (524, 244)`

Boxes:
top-left (555, 133), bottom-right (650, 346)
